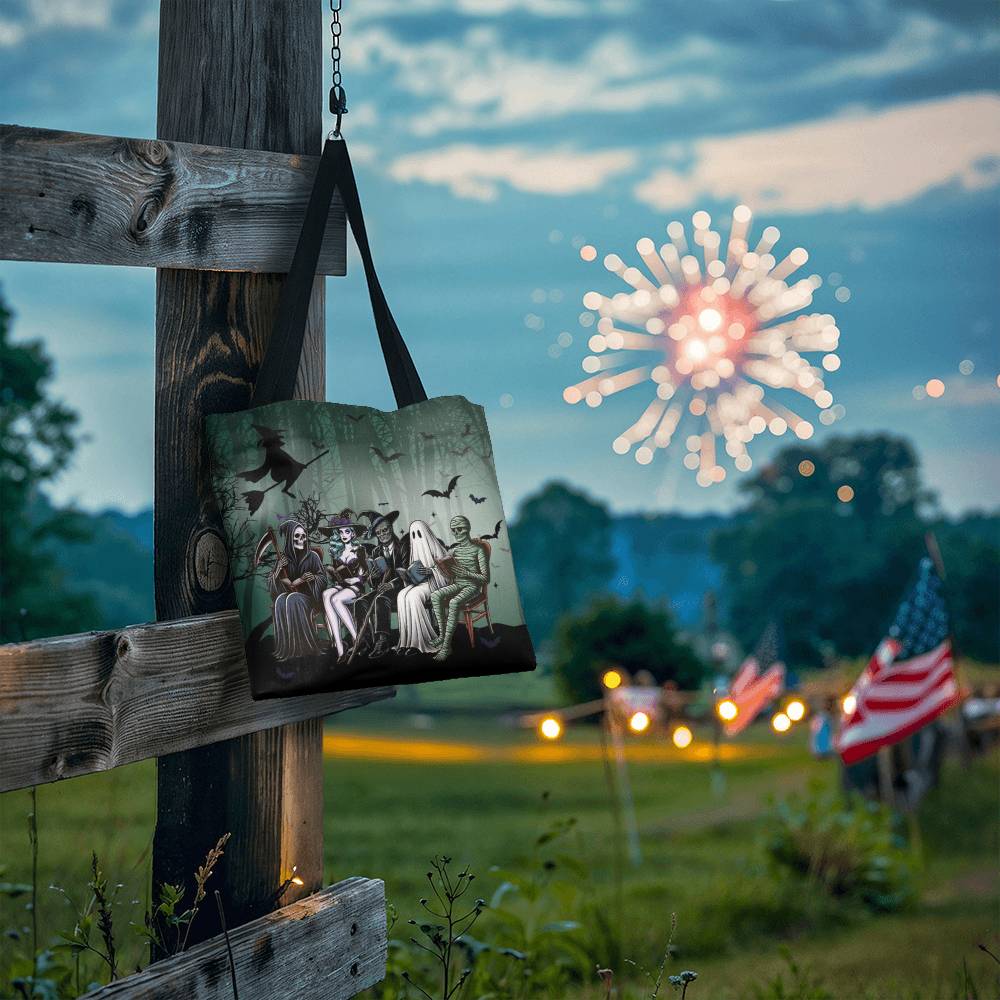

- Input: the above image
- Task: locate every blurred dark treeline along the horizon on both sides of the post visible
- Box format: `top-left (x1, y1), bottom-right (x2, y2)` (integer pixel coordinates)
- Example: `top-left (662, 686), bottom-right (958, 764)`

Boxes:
top-left (0, 286), bottom-right (1000, 680)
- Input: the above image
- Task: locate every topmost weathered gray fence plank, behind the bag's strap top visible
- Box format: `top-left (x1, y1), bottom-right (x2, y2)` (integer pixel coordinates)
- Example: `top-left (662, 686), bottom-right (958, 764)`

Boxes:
top-left (0, 125), bottom-right (346, 274)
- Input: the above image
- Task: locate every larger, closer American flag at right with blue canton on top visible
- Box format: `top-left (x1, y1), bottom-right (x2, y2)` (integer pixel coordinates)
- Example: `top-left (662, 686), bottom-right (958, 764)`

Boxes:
top-left (837, 558), bottom-right (961, 764)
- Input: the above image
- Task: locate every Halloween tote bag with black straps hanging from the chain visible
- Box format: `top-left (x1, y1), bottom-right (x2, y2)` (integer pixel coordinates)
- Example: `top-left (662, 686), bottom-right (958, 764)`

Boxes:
top-left (206, 139), bottom-right (535, 698)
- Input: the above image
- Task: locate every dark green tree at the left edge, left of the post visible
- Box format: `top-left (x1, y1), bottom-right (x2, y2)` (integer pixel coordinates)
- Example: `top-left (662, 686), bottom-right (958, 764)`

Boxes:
top-left (0, 286), bottom-right (97, 642)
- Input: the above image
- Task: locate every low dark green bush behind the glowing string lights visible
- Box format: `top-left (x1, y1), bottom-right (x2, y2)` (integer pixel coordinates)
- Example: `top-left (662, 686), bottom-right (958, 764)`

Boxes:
top-left (553, 596), bottom-right (705, 701)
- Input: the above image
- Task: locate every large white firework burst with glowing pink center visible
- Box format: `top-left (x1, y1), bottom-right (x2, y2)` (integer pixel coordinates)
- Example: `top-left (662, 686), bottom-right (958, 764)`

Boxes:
top-left (563, 205), bottom-right (840, 486)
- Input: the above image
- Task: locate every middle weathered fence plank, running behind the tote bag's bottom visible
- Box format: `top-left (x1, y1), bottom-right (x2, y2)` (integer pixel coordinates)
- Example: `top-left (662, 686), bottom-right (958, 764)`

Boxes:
top-left (0, 611), bottom-right (393, 792)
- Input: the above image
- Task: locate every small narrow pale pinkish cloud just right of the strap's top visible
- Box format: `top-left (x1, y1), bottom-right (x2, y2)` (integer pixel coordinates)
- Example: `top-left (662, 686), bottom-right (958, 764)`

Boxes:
top-left (389, 143), bottom-right (636, 201)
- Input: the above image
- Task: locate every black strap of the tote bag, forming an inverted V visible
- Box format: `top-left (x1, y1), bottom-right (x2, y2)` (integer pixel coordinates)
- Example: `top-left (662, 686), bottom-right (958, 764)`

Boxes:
top-left (251, 139), bottom-right (427, 407)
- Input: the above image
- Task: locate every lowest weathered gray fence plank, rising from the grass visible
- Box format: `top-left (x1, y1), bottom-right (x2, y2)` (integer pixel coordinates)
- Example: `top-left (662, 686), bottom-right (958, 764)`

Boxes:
top-left (86, 878), bottom-right (386, 1000)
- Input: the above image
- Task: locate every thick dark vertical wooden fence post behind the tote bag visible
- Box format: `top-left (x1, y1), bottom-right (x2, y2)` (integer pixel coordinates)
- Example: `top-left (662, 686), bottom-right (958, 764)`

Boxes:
top-left (153, 0), bottom-right (324, 941)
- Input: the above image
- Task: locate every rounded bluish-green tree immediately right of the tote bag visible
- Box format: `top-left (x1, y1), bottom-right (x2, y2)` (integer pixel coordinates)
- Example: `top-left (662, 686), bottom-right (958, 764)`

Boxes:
top-left (510, 482), bottom-right (615, 643)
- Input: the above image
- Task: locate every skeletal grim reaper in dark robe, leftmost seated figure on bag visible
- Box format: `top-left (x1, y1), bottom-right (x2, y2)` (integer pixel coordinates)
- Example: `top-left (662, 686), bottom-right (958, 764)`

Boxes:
top-left (267, 518), bottom-right (326, 660)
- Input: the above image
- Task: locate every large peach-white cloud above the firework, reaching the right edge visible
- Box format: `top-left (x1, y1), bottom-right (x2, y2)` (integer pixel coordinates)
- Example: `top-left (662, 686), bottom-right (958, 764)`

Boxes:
top-left (635, 93), bottom-right (1000, 213)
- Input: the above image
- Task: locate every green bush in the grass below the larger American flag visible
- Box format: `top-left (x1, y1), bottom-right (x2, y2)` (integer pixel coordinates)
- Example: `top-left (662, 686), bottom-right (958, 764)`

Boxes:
top-left (767, 784), bottom-right (913, 912)
